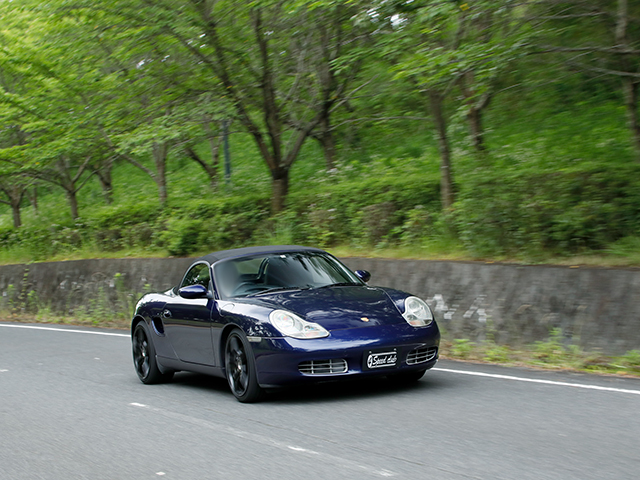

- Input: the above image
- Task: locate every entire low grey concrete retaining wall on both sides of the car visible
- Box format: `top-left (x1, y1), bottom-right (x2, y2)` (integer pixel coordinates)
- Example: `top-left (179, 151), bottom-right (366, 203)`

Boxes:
top-left (0, 258), bottom-right (640, 354)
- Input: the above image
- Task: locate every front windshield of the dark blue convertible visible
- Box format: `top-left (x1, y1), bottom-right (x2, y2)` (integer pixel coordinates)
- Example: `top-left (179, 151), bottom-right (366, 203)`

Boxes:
top-left (214, 252), bottom-right (363, 299)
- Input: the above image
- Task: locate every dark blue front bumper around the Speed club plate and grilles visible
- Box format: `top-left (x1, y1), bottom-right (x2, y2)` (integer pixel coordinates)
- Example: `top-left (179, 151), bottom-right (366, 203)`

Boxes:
top-left (251, 322), bottom-right (440, 388)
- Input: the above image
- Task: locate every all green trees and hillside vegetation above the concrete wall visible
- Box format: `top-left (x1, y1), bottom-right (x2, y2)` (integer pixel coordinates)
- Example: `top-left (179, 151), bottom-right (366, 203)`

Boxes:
top-left (0, 0), bottom-right (640, 265)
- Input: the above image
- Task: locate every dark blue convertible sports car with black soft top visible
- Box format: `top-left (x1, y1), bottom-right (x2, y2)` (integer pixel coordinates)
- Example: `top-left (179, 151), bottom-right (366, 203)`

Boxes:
top-left (131, 246), bottom-right (440, 402)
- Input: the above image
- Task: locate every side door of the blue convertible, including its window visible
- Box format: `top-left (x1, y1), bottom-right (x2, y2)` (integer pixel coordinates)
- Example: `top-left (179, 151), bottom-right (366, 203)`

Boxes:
top-left (162, 263), bottom-right (215, 365)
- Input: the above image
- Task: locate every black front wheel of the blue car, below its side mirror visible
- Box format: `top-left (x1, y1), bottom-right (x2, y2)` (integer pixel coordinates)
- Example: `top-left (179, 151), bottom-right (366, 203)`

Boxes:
top-left (224, 330), bottom-right (264, 403)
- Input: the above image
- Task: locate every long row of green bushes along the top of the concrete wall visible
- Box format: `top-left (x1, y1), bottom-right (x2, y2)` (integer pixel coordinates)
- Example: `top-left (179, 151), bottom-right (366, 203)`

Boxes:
top-left (0, 157), bottom-right (640, 264)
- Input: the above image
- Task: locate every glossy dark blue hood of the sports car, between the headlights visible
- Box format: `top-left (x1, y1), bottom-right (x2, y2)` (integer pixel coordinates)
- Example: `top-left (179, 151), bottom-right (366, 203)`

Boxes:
top-left (236, 286), bottom-right (404, 330)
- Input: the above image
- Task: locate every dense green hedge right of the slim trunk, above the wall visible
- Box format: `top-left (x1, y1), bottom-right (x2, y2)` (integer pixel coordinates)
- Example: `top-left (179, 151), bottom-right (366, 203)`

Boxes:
top-left (455, 158), bottom-right (640, 256)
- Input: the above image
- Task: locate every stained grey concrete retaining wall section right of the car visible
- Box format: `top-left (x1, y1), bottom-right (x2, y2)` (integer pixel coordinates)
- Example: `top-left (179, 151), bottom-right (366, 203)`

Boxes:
top-left (345, 259), bottom-right (640, 354)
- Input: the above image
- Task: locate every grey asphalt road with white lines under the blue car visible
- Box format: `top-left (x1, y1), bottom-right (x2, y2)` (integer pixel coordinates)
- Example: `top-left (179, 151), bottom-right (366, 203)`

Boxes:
top-left (0, 324), bottom-right (640, 480)
